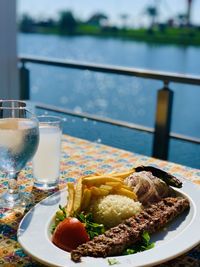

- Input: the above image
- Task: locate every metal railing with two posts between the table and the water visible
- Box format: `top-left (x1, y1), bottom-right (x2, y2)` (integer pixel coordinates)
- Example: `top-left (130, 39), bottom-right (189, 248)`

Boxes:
top-left (19, 56), bottom-right (200, 159)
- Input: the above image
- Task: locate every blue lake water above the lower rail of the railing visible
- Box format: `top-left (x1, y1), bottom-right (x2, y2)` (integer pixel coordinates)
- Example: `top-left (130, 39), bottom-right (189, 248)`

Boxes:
top-left (18, 34), bottom-right (200, 138)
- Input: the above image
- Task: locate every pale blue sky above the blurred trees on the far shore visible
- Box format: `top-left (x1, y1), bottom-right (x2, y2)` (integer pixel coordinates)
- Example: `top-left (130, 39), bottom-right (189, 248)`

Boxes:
top-left (17, 0), bottom-right (200, 26)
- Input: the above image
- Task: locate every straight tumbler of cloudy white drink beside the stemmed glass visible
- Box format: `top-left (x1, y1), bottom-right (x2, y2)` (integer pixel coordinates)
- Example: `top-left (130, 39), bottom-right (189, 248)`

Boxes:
top-left (33, 115), bottom-right (62, 190)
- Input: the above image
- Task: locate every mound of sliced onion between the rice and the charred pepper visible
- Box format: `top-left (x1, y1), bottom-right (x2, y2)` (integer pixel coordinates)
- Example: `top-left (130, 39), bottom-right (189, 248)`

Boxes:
top-left (124, 171), bottom-right (172, 205)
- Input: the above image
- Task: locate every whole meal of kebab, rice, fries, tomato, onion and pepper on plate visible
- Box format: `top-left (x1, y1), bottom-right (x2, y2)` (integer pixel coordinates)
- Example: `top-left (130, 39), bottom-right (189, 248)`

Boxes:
top-left (52, 166), bottom-right (189, 262)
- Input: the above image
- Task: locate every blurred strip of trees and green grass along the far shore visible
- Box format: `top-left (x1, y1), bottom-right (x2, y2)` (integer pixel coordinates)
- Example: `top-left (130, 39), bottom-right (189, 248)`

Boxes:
top-left (19, 11), bottom-right (200, 46)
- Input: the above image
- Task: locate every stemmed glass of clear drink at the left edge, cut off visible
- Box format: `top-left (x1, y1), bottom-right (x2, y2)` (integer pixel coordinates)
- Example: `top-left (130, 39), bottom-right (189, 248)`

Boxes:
top-left (0, 100), bottom-right (39, 209)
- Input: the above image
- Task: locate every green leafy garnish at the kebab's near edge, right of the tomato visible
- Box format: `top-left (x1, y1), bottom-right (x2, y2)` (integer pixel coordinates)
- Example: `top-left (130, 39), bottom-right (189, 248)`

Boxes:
top-left (123, 231), bottom-right (155, 255)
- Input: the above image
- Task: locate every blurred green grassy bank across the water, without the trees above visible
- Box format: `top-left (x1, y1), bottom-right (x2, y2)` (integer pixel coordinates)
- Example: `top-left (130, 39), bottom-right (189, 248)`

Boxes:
top-left (21, 24), bottom-right (200, 46)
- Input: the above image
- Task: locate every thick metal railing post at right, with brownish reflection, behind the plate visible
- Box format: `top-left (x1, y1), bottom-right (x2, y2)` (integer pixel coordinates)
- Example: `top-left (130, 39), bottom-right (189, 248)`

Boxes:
top-left (152, 81), bottom-right (174, 160)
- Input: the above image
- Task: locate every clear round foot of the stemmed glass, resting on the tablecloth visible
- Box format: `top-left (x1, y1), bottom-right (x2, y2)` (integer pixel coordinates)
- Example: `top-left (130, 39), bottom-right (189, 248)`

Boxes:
top-left (0, 192), bottom-right (34, 209)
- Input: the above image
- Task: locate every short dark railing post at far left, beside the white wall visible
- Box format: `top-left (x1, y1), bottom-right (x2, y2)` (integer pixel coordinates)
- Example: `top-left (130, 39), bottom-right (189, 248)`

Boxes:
top-left (19, 62), bottom-right (30, 100)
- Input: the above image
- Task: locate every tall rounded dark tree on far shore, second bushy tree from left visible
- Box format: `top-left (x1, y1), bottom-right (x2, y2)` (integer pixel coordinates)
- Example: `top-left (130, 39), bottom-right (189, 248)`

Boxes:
top-left (58, 11), bottom-right (77, 34)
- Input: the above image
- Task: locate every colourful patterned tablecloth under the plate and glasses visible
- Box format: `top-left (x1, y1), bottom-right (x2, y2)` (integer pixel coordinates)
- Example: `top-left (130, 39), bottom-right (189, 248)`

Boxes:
top-left (0, 136), bottom-right (200, 267)
